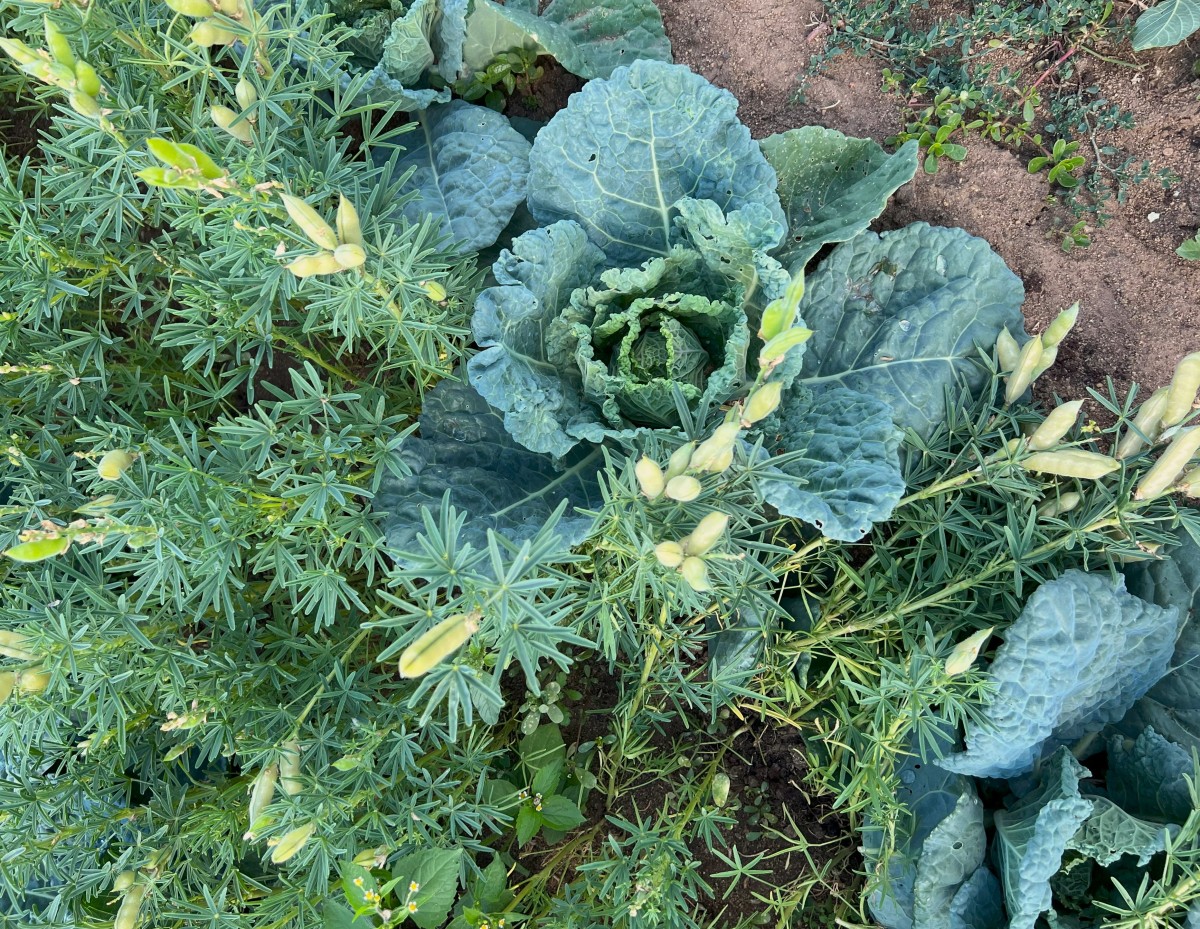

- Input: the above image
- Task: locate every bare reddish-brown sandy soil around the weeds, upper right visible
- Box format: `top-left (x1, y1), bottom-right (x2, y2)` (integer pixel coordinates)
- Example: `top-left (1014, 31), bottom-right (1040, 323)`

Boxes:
top-left (658, 0), bottom-right (1200, 397)
